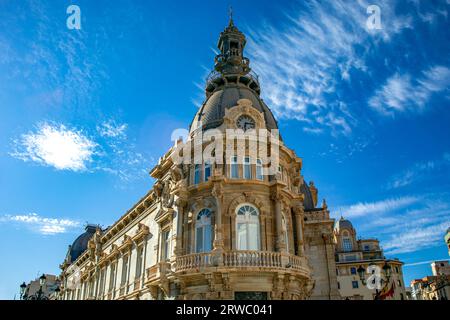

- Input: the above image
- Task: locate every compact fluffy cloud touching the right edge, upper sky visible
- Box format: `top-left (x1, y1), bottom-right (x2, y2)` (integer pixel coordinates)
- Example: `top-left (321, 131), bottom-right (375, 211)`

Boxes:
top-left (369, 66), bottom-right (450, 116)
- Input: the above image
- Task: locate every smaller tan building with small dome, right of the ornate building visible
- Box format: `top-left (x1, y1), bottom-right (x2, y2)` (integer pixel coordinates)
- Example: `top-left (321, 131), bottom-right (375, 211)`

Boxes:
top-left (334, 217), bottom-right (406, 300)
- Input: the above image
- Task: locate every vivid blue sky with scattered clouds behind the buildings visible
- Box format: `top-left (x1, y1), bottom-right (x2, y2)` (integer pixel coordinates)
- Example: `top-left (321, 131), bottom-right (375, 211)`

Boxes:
top-left (0, 0), bottom-right (450, 299)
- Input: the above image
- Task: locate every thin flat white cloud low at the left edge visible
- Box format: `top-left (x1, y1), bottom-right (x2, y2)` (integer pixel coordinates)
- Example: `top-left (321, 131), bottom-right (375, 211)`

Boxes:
top-left (0, 213), bottom-right (80, 235)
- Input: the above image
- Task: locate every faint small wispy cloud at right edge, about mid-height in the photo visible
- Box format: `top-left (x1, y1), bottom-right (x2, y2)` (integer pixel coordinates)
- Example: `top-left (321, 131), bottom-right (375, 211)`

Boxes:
top-left (387, 153), bottom-right (450, 189)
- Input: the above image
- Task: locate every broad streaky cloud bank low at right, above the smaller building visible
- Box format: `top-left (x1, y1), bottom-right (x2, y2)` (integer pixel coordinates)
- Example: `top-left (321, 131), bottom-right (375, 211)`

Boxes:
top-left (338, 193), bottom-right (450, 255)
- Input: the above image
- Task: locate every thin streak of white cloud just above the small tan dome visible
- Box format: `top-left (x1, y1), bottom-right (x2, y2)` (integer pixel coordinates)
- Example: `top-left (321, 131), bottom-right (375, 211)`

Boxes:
top-left (338, 196), bottom-right (420, 218)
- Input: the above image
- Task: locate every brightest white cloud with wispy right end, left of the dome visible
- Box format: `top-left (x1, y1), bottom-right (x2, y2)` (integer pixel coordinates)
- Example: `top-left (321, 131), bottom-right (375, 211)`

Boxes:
top-left (10, 119), bottom-right (155, 182)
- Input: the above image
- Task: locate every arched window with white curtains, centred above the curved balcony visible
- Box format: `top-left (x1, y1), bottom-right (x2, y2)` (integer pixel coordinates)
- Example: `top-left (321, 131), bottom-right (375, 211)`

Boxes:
top-left (236, 204), bottom-right (260, 250)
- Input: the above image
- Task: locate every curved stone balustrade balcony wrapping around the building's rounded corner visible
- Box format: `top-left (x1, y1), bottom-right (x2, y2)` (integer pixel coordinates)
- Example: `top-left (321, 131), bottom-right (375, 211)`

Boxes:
top-left (175, 251), bottom-right (309, 276)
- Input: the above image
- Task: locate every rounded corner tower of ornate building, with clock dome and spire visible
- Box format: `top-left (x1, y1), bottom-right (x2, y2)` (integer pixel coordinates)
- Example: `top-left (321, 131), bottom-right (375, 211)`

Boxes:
top-left (151, 18), bottom-right (338, 299)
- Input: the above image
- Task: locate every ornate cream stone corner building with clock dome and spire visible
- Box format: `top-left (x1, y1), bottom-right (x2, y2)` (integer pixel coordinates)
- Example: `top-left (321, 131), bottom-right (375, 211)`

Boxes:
top-left (61, 20), bottom-right (340, 300)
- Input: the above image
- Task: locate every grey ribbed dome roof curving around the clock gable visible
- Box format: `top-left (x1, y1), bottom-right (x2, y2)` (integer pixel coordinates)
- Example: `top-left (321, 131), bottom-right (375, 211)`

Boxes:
top-left (190, 84), bottom-right (278, 133)
